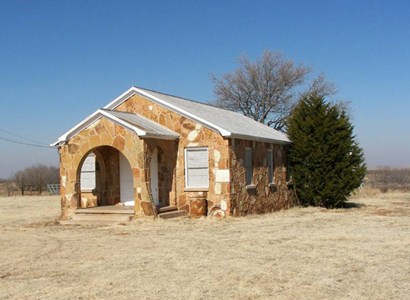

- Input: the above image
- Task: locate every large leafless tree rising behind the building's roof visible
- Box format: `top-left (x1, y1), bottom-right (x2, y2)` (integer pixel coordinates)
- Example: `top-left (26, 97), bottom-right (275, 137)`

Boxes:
top-left (212, 51), bottom-right (335, 130)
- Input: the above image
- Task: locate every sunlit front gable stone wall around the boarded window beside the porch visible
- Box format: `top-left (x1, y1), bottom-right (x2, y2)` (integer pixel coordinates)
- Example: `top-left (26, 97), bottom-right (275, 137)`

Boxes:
top-left (115, 95), bottom-right (230, 212)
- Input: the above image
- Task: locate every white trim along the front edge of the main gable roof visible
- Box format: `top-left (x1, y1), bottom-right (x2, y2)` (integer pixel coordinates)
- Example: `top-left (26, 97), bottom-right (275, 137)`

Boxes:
top-left (104, 86), bottom-right (232, 137)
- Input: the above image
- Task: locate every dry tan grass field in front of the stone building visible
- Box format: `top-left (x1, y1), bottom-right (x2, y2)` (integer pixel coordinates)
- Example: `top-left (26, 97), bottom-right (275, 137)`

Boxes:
top-left (0, 193), bottom-right (410, 299)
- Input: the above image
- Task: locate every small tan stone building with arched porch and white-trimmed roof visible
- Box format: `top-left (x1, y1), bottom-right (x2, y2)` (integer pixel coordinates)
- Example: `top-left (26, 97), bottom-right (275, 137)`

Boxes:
top-left (53, 87), bottom-right (294, 219)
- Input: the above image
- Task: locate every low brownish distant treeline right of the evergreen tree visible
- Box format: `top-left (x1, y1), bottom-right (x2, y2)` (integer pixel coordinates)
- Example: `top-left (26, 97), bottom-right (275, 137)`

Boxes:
top-left (365, 167), bottom-right (410, 192)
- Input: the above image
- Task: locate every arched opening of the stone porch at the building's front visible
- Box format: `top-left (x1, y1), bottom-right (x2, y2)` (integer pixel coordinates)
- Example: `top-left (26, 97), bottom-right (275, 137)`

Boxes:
top-left (77, 146), bottom-right (135, 208)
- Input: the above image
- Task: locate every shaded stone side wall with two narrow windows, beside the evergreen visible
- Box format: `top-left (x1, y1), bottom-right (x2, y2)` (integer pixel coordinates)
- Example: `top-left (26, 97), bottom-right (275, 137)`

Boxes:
top-left (229, 140), bottom-right (296, 216)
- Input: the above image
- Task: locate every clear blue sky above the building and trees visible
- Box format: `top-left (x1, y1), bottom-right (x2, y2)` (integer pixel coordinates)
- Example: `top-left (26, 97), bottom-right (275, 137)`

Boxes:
top-left (0, 0), bottom-right (410, 178)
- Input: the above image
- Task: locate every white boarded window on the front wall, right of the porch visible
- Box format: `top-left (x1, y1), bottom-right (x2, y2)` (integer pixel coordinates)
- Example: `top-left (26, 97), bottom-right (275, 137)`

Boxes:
top-left (185, 148), bottom-right (209, 188)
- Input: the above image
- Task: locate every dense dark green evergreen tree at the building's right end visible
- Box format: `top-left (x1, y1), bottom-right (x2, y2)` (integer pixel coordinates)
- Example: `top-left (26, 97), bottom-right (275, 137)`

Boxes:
top-left (288, 95), bottom-right (366, 208)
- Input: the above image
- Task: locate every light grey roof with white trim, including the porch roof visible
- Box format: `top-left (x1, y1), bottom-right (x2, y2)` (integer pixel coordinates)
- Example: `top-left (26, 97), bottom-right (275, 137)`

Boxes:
top-left (52, 87), bottom-right (290, 146)
